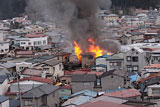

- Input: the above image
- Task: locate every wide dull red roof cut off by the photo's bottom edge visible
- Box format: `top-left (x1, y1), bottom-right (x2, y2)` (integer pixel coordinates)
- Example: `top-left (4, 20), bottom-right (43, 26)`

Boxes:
top-left (77, 100), bottom-right (134, 107)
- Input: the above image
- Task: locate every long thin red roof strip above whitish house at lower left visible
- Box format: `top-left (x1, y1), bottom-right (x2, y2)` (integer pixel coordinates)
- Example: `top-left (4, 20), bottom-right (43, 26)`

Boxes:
top-left (10, 77), bottom-right (52, 84)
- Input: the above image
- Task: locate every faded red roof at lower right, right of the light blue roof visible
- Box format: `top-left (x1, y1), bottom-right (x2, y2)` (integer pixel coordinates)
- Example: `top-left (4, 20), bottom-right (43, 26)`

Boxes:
top-left (104, 89), bottom-right (141, 98)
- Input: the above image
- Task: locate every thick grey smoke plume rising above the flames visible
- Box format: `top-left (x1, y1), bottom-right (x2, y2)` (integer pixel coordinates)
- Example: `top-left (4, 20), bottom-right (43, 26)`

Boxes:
top-left (26, 0), bottom-right (119, 50)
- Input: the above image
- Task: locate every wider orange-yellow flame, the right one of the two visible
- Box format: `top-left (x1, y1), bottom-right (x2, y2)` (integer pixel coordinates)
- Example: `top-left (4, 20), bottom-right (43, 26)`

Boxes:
top-left (88, 38), bottom-right (103, 57)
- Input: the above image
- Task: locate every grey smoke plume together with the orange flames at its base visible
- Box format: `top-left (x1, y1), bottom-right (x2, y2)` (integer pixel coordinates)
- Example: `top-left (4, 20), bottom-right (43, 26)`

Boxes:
top-left (27, 0), bottom-right (118, 66)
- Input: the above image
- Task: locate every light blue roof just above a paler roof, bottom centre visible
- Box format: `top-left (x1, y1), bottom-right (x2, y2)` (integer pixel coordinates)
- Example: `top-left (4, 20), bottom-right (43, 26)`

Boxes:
top-left (71, 90), bottom-right (97, 97)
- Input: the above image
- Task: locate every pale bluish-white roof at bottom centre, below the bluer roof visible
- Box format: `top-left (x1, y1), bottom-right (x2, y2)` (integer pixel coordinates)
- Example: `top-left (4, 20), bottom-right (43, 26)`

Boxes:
top-left (73, 96), bottom-right (92, 105)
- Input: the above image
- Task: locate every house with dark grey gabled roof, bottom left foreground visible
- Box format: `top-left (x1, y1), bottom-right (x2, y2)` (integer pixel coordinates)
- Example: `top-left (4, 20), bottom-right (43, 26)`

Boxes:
top-left (21, 84), bottom-right (60, 107)
